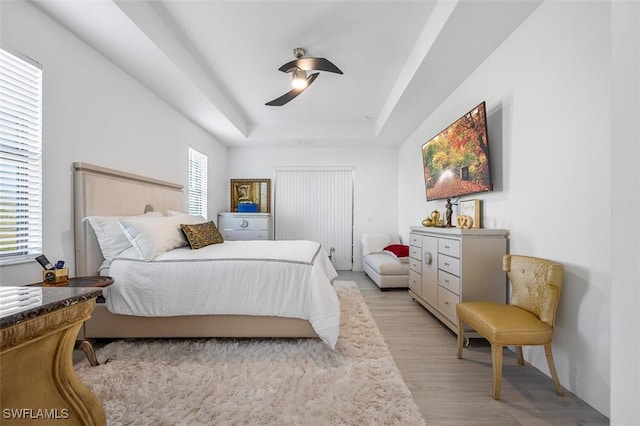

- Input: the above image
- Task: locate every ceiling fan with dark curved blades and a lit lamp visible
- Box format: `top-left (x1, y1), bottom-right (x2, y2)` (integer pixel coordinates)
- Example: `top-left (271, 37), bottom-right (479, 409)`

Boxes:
top-left (265, 47), bottom-right (343, 106)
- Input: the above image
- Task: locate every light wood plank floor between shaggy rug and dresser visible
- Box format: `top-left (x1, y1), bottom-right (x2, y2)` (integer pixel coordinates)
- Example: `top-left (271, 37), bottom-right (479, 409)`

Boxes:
top-left (338, 272), bottom-right (609, 426)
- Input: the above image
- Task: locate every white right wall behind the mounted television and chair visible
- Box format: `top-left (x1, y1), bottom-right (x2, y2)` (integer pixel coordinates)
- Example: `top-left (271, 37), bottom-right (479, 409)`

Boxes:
top-left (399, 2), bottom-right (612, 415)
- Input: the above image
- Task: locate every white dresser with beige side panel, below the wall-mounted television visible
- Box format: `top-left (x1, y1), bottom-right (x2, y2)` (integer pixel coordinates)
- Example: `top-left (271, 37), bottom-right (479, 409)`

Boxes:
top-left (409, 226), bottom-right (508, 334)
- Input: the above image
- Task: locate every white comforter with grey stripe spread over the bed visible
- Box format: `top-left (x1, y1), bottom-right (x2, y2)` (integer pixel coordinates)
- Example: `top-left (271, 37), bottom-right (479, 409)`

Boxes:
top-left (103, 241), bottom-right (340, 348)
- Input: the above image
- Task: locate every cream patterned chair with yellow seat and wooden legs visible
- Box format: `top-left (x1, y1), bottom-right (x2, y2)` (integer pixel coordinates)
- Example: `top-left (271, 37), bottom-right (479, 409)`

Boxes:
top-left (456, 255), bottom-right (564, 399)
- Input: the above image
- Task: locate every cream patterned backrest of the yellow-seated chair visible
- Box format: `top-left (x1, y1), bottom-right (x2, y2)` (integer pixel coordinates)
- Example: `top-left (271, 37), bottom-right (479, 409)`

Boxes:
top-left (502, 254), bottom-right (564, 327)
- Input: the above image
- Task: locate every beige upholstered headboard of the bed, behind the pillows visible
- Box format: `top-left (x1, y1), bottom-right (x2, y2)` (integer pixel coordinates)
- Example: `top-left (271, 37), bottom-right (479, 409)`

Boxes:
top-left (73, 163), bottom-right (185, 277)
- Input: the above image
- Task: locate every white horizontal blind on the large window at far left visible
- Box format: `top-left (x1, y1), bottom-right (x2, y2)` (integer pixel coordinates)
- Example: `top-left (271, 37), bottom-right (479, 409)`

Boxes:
top-left (0, 48), bottom-right (42, 263)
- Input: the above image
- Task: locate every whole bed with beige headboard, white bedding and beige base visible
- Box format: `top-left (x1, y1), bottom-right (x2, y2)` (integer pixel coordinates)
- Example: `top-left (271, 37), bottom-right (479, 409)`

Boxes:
top-left (73, 163), bottom-right (340, 348)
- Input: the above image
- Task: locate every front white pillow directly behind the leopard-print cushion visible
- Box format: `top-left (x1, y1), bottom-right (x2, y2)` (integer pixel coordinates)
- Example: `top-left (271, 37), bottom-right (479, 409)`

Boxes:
top-left (119, 214), bottom-right (206, 260)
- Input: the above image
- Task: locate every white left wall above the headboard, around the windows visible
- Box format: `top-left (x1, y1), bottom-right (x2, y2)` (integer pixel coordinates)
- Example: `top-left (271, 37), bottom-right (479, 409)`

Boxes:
top-left (0, 2), bottom-right (227, 285)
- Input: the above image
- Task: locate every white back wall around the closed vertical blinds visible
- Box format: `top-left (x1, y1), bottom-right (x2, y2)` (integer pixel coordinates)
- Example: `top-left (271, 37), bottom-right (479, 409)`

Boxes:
top-left (225, 147), bottom-right (398, 271)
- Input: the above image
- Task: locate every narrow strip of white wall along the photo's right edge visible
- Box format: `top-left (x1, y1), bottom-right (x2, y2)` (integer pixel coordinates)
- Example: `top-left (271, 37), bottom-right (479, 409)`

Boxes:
top-left (611, 2), bottom-right (640, 425)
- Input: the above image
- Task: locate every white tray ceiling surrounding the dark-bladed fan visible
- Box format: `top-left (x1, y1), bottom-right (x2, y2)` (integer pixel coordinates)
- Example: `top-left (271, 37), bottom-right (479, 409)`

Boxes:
top-left (32, 0), bottom-right (541, 147)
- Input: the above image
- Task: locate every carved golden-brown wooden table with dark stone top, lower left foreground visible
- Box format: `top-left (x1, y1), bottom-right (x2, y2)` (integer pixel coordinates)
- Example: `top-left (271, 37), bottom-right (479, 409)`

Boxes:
top-left (0, 286), bottom-right (106, 425)
